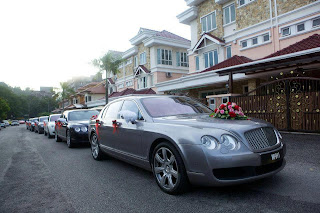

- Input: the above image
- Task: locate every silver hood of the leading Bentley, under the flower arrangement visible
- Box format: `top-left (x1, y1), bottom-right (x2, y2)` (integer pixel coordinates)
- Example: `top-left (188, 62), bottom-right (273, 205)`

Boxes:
top-left (154, 114), bottom-right (272, 132)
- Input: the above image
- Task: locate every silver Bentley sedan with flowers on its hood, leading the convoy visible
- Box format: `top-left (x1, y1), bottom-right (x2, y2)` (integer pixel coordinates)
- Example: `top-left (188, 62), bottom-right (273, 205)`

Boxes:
top-left (88, 95), bottom-right (286, 194)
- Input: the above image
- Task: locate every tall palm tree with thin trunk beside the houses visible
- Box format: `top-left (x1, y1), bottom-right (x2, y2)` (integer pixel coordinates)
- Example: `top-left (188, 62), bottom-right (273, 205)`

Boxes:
top-left (92, 51), bottom-right (124, 104)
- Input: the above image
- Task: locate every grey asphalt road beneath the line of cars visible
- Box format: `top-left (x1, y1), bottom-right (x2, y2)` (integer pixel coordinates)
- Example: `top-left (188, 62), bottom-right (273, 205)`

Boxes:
top-left (0, 126), bottom-right (320, 213)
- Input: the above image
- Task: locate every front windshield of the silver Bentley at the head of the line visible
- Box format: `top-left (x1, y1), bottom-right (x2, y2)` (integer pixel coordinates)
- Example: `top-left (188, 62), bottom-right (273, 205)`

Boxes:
top-left (142, 97), bottom-right (212, 117)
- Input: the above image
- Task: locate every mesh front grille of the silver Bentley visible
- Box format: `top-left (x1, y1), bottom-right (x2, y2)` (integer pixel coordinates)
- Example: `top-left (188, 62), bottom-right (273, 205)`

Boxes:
top-left (244, 127), bottom-right (277, 150)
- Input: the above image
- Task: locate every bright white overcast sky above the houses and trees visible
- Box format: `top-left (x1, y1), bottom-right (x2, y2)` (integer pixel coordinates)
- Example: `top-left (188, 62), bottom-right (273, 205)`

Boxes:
top-left (0, 0), bottom-right (191, 90)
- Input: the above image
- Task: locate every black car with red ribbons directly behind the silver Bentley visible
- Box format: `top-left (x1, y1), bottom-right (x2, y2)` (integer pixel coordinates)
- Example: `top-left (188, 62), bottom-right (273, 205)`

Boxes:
top-left (55, 109), bottom-right (99, 148)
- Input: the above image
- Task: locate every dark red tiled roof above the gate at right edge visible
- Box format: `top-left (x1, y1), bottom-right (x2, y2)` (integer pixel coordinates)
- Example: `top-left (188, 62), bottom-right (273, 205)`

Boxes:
top-left (263, 34), bottom-right (320, 59)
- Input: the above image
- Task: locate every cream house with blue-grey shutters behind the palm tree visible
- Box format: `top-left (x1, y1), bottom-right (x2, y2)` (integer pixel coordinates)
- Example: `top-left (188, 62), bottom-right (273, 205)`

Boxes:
top-left (108, 28), bottom-right (191, 94)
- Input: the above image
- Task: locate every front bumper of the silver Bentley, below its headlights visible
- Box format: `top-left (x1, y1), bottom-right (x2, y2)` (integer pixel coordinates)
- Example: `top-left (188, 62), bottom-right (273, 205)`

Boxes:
top-left (184, 144), bottom-right (286, 186)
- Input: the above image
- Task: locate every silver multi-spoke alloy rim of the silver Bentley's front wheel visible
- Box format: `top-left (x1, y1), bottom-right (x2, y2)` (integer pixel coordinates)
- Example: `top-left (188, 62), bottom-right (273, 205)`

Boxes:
top-left (153, 147), bottom-right (179, 190)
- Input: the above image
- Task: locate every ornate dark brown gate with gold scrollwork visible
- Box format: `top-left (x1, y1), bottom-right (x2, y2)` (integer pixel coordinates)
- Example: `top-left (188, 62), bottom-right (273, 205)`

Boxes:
top-left (230, 77), bottom-right (320, 132)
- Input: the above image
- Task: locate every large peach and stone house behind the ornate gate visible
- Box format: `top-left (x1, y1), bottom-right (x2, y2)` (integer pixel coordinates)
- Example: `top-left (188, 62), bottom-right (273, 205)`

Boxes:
top-left (156, 0), bottom-right (320, 132)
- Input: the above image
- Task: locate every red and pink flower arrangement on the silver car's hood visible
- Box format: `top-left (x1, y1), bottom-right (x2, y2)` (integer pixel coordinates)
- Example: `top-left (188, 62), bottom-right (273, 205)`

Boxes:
top-left (210, 102), bottom-right (248, 120)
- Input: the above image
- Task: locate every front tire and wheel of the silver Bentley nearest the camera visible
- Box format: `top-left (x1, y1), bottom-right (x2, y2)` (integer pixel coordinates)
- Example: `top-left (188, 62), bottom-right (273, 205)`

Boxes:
top-left (151, 142), bottom-right (190, 195)
